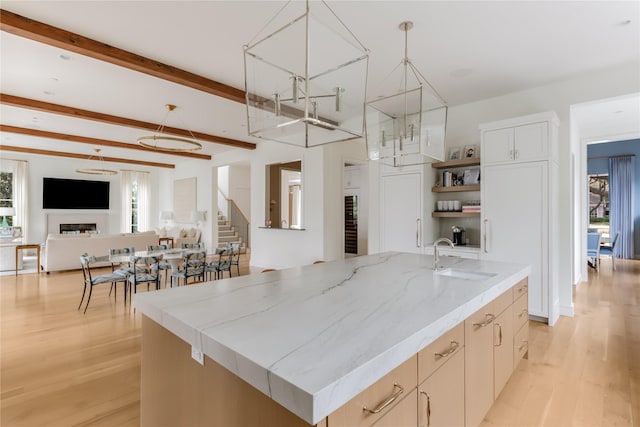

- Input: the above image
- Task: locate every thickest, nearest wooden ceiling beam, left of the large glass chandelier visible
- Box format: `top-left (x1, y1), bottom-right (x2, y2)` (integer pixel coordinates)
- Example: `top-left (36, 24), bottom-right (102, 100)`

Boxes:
top-left (0, 9), bottom-right (245, 104)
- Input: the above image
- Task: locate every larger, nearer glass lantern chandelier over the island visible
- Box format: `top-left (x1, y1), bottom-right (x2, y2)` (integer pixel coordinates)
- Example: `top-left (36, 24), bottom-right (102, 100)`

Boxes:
top-left (243, 0), bottom-right (369, 148)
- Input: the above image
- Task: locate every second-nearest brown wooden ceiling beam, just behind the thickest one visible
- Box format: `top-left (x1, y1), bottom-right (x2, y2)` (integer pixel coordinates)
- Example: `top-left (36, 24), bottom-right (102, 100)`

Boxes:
top-left (0, 93), bottom-right (256, 150)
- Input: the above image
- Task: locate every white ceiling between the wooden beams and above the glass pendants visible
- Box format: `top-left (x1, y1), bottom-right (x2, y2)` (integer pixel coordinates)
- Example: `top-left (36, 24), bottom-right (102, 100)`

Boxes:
top-left (0, 0), bottom-right (640, 169)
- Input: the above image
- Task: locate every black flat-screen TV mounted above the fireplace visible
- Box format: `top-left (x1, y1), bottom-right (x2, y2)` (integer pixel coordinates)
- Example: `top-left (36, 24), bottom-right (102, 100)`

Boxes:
top-left (42, 178), bottom-right (110, 209)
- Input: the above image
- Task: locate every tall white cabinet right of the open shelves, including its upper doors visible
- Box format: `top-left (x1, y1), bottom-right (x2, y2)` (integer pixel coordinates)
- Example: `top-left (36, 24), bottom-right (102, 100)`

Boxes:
top-left (480, 112), bottom-right (559, 325)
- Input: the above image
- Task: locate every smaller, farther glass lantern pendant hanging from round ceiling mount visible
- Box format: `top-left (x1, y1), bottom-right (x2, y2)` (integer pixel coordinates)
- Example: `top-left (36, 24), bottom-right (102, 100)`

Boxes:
top-left (366, 21), bottom-right (448, 167)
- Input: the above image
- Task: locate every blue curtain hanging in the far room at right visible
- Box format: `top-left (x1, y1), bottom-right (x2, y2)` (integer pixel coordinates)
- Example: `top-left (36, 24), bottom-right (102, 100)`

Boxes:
top-left (609, 156), bottom-right (634, 259)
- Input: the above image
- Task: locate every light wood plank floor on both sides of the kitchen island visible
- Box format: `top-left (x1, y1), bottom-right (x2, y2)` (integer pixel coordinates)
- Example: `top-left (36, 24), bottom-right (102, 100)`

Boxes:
top-left (0, 255), bottom-right (640, 427)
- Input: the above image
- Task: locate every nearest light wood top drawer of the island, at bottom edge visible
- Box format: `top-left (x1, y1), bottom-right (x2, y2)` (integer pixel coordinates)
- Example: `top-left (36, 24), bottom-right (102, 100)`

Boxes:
top-left (327, 355), bottom-right (418, 427)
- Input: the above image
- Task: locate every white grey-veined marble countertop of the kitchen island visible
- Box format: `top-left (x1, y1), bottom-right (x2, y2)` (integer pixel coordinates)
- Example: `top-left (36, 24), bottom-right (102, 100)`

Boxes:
top-left (134, 252), bottom-right (530, 424)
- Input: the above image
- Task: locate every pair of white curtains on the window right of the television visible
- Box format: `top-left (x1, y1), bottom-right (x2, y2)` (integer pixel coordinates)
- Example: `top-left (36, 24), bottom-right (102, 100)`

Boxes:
top-left (120, 170), bottom-right (151, 233)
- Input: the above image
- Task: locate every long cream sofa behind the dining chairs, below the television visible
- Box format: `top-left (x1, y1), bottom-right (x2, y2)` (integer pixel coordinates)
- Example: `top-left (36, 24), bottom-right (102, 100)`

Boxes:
top-left (40, 231), bottom-right (159, 273)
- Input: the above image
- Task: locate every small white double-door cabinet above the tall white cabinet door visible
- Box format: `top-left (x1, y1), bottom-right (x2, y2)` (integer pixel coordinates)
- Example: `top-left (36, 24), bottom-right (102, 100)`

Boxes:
top-left (481, 121), bottom-right (549, 164)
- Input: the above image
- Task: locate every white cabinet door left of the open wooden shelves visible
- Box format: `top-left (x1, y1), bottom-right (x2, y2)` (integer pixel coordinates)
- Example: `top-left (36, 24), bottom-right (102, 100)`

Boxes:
top-left (380, 169), bottom-right (423, 253)
